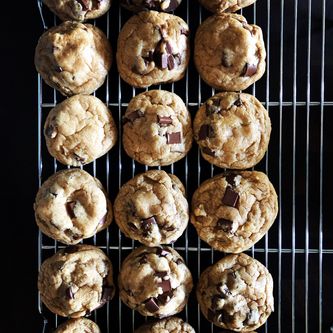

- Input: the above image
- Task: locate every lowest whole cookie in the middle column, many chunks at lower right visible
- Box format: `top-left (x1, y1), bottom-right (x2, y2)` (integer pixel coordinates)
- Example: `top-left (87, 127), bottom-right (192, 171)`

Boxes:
top-left (118, 246), bottom-right (193, 318)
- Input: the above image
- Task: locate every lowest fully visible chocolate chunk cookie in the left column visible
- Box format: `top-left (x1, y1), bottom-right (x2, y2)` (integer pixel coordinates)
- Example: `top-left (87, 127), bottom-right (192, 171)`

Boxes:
top-left (38, 245), bottom-right (115, 318)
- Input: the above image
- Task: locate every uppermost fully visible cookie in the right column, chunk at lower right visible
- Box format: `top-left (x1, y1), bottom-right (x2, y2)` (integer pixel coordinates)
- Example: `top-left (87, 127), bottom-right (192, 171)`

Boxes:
top-left (194, 14), bottom-right (266, 91)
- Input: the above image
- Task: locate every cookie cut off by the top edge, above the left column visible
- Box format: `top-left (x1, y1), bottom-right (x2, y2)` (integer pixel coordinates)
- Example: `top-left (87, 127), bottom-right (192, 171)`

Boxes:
top-left (43, 0), bottom-right (111, 21)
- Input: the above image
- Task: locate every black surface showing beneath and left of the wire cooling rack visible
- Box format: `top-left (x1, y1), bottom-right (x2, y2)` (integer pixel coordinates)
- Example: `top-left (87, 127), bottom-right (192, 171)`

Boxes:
top-left (1, 0), bottom-right (333, 333)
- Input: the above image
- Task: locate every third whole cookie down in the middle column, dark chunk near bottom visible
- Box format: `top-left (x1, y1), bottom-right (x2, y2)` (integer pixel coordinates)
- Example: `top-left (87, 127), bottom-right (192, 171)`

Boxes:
top-left (114, 170), bottom-right (189, 246)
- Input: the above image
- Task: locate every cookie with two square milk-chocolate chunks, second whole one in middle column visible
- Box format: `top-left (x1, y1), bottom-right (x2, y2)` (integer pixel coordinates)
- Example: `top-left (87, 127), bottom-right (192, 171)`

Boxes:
top-left (123, 90), bottom-right (192, 166)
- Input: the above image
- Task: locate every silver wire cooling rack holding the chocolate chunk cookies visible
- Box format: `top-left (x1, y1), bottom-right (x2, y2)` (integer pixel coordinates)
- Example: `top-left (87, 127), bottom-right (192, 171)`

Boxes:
top-left (37, 0), bottom-right (333, 333)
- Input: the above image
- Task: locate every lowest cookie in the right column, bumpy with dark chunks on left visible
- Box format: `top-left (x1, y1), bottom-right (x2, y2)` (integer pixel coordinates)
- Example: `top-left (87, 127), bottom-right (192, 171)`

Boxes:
top-left (196, 253), bottom-right (274, 332)
